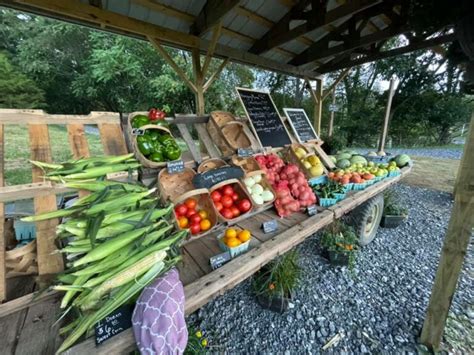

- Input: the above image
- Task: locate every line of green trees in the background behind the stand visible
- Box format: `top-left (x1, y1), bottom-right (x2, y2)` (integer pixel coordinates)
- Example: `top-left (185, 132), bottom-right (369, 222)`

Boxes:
top-left (0, 8), bottom-right (473, 147)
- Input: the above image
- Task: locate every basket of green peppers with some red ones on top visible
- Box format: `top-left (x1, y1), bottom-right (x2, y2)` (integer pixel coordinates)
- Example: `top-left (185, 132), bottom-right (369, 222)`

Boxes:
top-left (128, 108), bottom-right (181, 168)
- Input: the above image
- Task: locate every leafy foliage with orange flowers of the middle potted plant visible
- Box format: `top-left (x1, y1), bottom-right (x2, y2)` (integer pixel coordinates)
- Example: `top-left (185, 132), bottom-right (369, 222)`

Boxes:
top-left (321, 221), bottom-right (358, 270)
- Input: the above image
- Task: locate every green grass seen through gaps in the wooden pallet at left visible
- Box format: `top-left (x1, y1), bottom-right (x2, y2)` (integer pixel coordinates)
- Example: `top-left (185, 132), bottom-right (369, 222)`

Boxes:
top-left (5, 125), bottom-right (103, 185)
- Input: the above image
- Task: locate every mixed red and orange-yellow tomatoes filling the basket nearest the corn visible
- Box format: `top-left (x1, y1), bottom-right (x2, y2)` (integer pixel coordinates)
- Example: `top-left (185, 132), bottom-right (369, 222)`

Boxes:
top-left (174, 198), bottom-right (212, 235)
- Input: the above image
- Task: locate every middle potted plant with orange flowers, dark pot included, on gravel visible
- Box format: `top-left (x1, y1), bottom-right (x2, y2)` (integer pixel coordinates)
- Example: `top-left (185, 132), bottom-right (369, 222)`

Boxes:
top-left (321, 221), bottom-right (357, 269)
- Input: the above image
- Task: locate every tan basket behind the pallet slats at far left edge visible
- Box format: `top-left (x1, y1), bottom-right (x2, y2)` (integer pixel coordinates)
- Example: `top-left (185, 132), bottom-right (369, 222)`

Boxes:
top-left (5, 240), bottom-right (38, 278)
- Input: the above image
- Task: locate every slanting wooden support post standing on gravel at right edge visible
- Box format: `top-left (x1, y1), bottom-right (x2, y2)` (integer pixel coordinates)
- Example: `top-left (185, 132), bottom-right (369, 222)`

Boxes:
top-left (420, 115), bottom-right (474, 350)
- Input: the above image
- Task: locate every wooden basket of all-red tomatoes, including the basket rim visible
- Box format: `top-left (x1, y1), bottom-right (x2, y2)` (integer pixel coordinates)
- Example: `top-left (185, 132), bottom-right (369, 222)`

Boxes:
top-left (210, 179), bottom-right (253, 223)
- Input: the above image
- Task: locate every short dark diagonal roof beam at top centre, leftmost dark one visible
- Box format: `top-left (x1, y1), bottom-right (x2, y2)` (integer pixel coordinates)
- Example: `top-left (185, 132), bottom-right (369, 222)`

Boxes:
top-left (190, 0), bottom-right (240, 36)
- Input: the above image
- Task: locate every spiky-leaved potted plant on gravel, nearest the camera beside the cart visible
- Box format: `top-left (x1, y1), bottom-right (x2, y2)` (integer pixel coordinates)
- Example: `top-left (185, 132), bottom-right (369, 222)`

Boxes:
top-left (252, 250), bottom-right (301, 313)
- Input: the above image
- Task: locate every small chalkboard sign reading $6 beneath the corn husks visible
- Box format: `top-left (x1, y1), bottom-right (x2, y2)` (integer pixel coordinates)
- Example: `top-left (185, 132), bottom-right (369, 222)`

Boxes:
top-left (95, 305), bottom-right (133, 345)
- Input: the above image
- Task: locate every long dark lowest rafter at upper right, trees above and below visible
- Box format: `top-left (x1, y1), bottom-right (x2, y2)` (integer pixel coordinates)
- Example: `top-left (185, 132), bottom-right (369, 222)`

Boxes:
top-left (317, 33), bottom-right (456, 73)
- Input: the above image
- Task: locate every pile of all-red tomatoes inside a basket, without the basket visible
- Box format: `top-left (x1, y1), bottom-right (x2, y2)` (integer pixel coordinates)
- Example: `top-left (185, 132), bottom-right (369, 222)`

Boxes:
top-left (211, 184), bottom-right (252, 219)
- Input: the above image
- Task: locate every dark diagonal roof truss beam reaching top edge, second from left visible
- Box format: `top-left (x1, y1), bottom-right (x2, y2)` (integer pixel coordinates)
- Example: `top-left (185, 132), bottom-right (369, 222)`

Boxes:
top-left (249, 0), bottom-right (381, 54)
